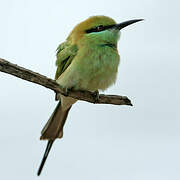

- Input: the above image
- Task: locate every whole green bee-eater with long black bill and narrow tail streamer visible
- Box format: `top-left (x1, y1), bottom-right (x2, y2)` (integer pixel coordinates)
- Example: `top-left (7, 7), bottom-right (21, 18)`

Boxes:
top-left (37, 15), bottom-right (143, 176)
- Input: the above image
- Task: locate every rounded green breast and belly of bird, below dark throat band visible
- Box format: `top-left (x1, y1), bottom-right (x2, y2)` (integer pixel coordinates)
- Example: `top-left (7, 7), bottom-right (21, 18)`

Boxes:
top-left (74, 45), bottom-right (120, 91)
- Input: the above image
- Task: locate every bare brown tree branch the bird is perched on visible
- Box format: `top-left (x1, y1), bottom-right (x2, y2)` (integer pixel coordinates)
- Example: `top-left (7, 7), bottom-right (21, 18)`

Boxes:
top-left (0, 58), bottom-right (132, 106)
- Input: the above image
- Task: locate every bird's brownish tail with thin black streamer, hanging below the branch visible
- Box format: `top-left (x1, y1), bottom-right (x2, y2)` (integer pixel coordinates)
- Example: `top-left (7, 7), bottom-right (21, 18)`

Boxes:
top-left (37, 102), bottom-right (71, 176)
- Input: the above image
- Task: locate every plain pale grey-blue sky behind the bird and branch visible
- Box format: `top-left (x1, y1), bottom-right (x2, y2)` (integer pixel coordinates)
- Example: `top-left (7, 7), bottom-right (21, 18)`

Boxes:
top-left (0, 0), bottom-right (180, 180)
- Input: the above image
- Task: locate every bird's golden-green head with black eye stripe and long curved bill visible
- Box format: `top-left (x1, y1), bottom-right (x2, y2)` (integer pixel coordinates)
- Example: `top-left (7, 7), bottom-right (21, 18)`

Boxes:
top-left (68, 16), bottom-right (143, 45)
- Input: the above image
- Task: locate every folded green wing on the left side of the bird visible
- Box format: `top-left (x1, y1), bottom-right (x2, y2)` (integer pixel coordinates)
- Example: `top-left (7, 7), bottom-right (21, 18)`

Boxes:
top-left (55, 41), bottom-right (78, 80)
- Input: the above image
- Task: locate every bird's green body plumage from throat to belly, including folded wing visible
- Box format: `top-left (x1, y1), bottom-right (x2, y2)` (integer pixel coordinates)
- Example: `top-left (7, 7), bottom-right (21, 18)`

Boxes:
top-left (56, 27), bottom-right (120, 91)
